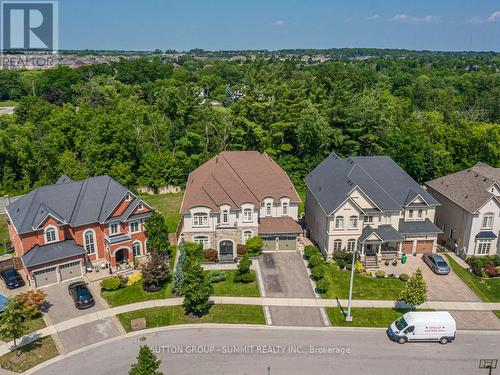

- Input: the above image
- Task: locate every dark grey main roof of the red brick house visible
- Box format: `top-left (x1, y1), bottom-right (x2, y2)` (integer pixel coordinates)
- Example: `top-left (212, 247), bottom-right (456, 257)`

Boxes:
top-left (7, 175), bottom-right (133, 233)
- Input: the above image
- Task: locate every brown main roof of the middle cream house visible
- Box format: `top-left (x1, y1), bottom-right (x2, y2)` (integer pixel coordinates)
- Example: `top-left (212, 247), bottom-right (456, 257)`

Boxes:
top-left (181, 151), bottom-right (300, 213)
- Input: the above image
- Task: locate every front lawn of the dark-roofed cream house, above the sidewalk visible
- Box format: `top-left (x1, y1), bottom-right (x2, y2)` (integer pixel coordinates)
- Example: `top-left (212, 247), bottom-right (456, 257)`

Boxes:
top-left (322, 264), bottom-right (405, 301)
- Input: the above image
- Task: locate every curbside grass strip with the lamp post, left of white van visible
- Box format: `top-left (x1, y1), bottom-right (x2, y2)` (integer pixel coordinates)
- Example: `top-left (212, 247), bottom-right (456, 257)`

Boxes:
top-left (326, 306), bottom-right (429, 328)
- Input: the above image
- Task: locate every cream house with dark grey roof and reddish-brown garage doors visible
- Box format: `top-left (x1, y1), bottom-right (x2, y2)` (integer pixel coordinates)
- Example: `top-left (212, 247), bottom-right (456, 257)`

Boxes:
top-left (305, 153), bottom-right (441, 266)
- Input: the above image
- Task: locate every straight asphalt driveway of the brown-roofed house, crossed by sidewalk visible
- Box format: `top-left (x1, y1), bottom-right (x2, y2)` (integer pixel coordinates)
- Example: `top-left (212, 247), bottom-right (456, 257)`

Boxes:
top-left (259, 252), bottom-right (325, 327)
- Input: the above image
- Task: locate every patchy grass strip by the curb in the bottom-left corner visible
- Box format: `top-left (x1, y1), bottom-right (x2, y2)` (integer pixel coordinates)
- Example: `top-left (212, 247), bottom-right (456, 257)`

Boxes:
top-left (0, 336), bottom-right (59, 372)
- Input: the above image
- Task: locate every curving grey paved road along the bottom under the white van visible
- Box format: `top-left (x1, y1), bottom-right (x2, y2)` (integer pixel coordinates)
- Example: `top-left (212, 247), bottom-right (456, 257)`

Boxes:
top-left (34, 327), bottom-right (500, 375)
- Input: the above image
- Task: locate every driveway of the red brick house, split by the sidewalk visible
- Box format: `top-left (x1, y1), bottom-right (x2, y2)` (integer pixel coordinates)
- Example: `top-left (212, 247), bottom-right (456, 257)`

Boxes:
top-left (43, 279), bottom-right (123, 353)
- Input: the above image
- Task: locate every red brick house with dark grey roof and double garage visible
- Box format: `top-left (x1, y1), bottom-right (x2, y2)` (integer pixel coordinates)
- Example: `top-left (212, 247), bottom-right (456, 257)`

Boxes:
top-left (7, 175), bottom-right (152, 287)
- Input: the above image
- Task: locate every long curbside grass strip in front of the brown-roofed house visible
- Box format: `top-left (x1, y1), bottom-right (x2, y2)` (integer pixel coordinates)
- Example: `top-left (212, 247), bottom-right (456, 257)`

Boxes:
top-left (118, 305), bottom-right (266, 332)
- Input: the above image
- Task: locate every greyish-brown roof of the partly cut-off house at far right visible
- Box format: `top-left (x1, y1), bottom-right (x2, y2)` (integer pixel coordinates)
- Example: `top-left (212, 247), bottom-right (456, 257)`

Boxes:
top-left (425, 162), bottom-right (500, 213)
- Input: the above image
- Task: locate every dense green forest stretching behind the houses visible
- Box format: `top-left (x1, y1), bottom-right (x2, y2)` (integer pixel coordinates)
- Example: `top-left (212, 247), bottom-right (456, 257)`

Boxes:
top-left (0, 53), bottom-right (500, 194)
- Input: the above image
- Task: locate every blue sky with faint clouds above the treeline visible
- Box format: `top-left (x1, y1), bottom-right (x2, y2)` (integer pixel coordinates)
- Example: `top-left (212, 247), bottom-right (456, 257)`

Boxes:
top-left (59, 0), bottom-right (500, 51)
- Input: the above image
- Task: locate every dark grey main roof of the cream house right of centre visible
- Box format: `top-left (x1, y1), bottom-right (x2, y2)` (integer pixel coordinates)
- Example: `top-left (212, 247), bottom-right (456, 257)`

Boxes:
top-left (305, 153), bottom-right (439, 215)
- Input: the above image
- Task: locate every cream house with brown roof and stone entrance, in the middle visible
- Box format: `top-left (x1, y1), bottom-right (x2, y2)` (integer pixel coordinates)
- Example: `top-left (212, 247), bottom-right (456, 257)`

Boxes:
top-left (179, 151), bottom-right (302, 261)
